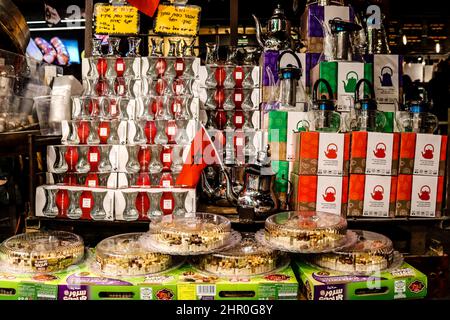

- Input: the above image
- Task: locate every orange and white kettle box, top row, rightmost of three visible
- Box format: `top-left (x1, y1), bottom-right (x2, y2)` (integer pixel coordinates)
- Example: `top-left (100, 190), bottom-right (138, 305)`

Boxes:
top-left (399, 132), bottom-right (447, 176)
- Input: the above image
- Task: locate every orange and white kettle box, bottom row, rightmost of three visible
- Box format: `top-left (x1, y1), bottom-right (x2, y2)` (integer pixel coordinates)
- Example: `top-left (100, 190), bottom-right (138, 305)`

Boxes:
top-left (395, 174), bottom-right (444, 218)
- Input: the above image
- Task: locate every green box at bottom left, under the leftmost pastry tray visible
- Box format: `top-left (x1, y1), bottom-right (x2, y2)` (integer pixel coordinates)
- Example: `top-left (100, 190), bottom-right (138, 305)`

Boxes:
top-left (0, 264), bottom-right (177, 301)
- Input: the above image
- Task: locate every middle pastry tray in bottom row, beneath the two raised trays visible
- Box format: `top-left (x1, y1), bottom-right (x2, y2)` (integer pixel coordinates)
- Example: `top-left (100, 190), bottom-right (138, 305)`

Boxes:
top-left (196, 233), bottom-right (280, 276)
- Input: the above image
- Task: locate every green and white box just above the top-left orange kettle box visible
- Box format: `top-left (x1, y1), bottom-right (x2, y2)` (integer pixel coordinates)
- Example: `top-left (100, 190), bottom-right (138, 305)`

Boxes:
top-left (263, 111), bottom-right (314, 161)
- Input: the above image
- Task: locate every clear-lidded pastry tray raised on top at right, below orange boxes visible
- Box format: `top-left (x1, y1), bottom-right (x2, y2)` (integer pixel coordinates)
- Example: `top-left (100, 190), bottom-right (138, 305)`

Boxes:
top-left (264, 211), bottom-right (347, 252)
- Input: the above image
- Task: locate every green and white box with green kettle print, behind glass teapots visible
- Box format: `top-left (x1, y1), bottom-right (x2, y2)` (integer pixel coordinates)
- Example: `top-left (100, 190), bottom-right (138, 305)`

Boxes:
top-left (311, 61), bottom-right (373, 111)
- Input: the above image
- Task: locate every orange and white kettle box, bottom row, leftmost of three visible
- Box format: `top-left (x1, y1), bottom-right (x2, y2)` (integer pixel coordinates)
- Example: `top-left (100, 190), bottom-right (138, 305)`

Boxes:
top-left (291, 173), bottom-right (348, 216)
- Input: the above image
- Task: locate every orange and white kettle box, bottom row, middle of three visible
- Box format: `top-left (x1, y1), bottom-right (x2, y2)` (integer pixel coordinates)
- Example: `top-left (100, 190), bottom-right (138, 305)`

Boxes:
top-left (347, 174), bottom-right (397, 217)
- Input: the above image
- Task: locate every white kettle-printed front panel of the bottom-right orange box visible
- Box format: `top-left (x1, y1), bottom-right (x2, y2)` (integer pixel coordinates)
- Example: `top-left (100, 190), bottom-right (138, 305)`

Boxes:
top-left (411, 176), bottom-right (438, 217)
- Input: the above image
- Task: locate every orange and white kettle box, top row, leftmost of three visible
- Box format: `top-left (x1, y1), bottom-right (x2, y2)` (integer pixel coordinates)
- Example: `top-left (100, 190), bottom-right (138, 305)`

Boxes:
top-left (293, 131), bottom-right (350, 176)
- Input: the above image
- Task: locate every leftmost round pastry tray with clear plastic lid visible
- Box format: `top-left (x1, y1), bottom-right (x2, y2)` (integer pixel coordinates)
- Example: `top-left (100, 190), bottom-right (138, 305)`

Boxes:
top-left (0, 231), bottom-right (84, 273)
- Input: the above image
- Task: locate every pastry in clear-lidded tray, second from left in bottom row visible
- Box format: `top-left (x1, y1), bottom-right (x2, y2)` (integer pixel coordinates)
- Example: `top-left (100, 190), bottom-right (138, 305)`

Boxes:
top-left (95, 233), bottom-right (172, 276)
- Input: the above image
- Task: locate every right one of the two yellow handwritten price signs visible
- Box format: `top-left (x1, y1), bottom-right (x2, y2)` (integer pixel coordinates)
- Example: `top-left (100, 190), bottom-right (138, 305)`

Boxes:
top-left (154, 4), bottom-right (201, 37)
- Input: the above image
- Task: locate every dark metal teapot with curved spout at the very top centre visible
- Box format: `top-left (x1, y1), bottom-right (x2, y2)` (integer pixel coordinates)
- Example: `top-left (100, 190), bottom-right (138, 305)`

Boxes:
top-left (252, 4), bottom-right (292, 51)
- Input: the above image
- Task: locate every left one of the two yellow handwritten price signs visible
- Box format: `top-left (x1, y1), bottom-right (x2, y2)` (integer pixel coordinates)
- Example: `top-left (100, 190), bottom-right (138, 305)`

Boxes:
top-left (94, 3), bottom-right (139, 35)
